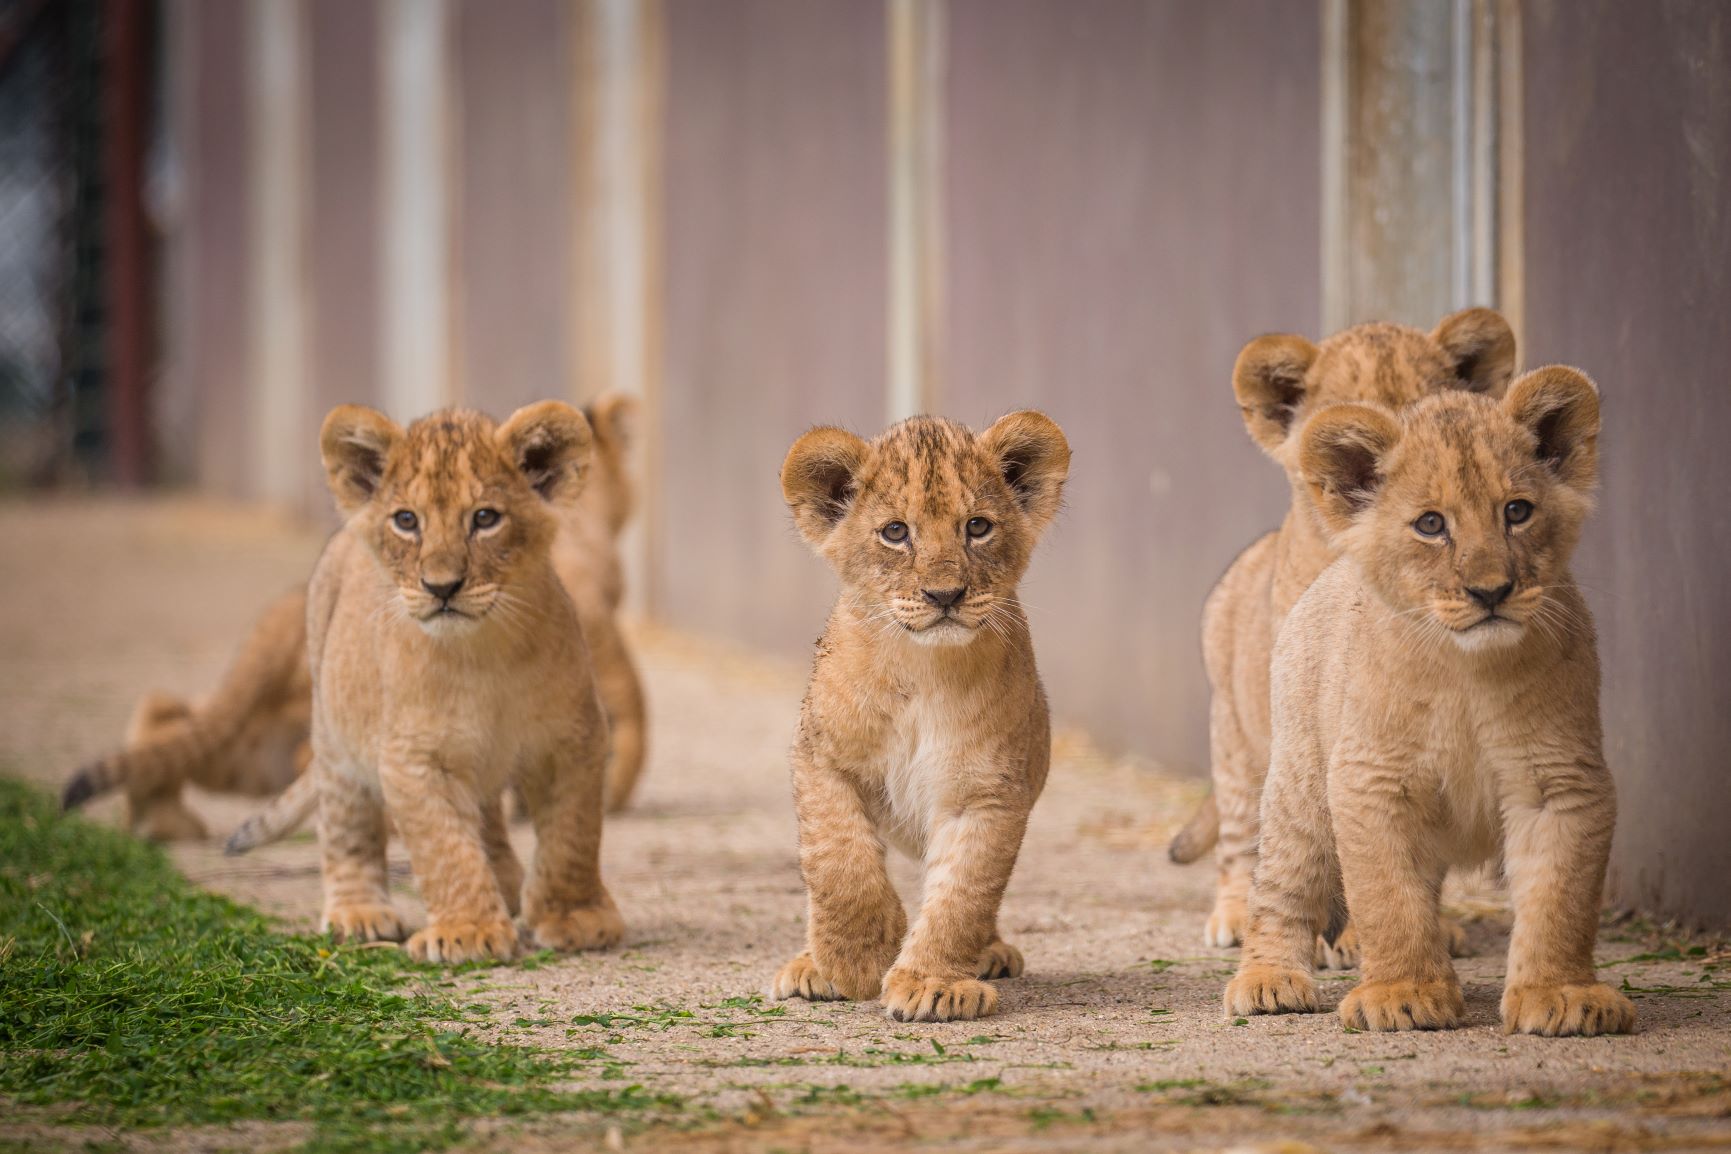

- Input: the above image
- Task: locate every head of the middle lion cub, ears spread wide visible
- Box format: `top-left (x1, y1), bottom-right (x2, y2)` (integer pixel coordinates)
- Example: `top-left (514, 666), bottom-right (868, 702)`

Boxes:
top-left (781, 412), bottom-right (1070, 645)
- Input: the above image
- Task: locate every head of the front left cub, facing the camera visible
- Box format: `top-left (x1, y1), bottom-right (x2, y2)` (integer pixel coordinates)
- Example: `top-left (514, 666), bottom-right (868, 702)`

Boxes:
top-left (319, 401), bottom-right (590, 635)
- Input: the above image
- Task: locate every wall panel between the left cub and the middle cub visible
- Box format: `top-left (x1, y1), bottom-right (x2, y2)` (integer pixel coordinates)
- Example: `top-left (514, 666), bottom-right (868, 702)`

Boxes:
top-left (651, 0), bottom-right (886, 652)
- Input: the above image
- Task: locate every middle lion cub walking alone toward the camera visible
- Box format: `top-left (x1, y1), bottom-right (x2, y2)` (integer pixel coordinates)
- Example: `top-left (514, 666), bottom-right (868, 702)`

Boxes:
top-left (769, 412), bottom-right (1070, 1021)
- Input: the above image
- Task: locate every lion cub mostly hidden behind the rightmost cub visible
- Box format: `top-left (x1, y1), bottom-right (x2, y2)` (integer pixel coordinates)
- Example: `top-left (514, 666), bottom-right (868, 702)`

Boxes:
top-left (1172, 308), bottom-right (1515, 965)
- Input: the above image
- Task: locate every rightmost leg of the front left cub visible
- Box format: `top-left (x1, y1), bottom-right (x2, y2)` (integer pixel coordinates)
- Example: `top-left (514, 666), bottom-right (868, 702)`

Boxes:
top-left (519, 730), bottom-right (625, 950)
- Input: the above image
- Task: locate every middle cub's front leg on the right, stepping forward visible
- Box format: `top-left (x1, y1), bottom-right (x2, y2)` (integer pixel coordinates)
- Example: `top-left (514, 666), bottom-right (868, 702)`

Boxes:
top-left (883, 801), bottom-right (1028, 1023)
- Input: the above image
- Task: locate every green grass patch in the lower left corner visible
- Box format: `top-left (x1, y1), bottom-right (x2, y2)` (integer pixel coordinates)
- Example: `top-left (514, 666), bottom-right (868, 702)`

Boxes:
top-left (0, 779), bottom-right (679, 1151)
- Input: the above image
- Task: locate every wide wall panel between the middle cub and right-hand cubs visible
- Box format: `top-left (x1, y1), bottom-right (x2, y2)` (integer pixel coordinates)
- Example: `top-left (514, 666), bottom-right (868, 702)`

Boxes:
top-left (940, 0), bottom-right (1321, 768)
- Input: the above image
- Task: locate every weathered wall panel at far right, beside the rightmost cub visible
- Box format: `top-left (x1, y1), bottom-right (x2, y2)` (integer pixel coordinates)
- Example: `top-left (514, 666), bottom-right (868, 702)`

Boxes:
top-left (1522, 0), bottom-right (1731, 926)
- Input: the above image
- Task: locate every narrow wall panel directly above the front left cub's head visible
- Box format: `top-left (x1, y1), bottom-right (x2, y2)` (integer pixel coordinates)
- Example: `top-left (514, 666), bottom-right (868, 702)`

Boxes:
top-left (454, 0), bottom-right (576, 417)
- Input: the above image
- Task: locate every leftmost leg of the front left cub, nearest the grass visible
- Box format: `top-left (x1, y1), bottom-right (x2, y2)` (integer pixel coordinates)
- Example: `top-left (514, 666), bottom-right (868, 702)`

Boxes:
top-left (310, 763), bottom-right (403, 941)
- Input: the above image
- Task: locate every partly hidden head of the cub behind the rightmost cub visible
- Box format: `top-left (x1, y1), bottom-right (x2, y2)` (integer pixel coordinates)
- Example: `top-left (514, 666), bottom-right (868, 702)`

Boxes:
top-left (1232, 308), bottom-right (1515, 474)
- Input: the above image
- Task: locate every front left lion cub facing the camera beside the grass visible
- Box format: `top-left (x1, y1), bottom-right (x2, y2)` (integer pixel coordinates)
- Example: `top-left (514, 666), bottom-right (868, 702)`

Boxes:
top-left (306, 401), bottom-right (623, 962)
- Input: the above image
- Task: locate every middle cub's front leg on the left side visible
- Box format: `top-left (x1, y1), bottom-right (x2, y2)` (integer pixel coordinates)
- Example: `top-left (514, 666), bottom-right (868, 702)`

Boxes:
top-left (769, 753), bottom-right (907, 1002)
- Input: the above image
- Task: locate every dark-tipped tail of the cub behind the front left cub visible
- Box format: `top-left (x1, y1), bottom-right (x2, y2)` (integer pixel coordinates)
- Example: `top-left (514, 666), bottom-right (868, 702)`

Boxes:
top-left (61, 590), bottom-right (306, 810)
